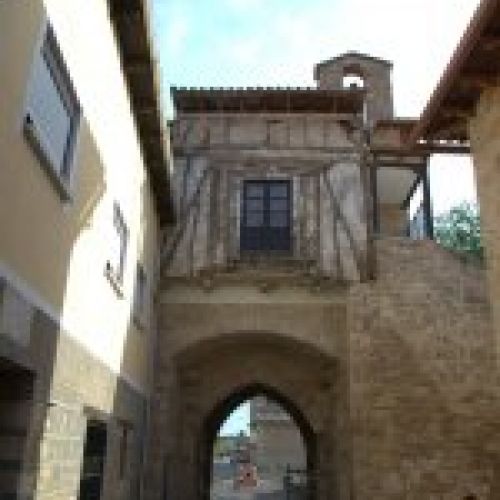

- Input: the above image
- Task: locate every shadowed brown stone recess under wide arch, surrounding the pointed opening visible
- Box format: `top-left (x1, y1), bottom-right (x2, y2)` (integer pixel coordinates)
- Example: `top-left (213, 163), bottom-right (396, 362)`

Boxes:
top-left (148, 331), bottom-right (350, 500)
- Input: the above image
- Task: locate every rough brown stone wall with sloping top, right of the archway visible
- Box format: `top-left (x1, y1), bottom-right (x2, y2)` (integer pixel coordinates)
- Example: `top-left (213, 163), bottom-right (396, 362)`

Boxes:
top-left (348, 239), bottom-right (500, 500)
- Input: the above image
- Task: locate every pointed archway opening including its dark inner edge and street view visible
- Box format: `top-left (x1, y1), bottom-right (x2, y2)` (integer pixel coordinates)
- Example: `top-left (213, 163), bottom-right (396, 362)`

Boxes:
top-left (201, 384), bottom-right (315, 500)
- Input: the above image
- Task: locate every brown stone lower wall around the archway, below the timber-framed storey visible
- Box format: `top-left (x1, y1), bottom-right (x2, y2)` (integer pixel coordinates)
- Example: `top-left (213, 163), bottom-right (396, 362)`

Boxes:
top-left (146, 238), bottom-right (500, 500)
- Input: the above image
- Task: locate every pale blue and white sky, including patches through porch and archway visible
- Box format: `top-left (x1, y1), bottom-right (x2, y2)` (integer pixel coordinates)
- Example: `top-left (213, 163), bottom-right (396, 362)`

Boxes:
top-left (150, 0), bottom-right (479, 432)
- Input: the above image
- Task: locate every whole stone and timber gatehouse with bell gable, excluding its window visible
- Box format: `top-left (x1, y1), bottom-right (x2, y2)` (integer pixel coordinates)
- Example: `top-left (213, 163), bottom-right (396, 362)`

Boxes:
top-left (145, 53), bottom-right (500, 500)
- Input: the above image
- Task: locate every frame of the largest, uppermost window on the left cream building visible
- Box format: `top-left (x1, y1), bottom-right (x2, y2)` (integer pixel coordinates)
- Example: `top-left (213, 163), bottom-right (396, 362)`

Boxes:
top-left (23, 22), bottom-right (82, 201)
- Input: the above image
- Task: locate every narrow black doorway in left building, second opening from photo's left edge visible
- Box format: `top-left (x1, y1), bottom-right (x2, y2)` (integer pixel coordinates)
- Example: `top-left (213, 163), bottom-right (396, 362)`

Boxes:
top-left (78, 420), bottom-right (108, 500)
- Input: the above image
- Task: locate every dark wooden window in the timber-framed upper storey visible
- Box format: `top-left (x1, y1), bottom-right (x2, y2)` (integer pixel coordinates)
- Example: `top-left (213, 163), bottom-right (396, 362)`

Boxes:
top-left (241, 180), bottom-right (291, 252)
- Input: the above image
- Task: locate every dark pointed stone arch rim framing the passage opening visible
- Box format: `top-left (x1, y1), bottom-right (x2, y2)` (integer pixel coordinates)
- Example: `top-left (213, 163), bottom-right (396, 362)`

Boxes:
top-left (199, 383), bottom-right (318, 500)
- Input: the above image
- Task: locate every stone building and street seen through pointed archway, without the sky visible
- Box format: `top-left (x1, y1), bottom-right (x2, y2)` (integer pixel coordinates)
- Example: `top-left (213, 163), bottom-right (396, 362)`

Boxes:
top-left (211, 394), bottom-right (306, 500)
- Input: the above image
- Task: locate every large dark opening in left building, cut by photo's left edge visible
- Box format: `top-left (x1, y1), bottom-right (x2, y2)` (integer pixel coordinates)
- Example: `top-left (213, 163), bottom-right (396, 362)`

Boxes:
top-left (0, 358), bottom-right (34, 499)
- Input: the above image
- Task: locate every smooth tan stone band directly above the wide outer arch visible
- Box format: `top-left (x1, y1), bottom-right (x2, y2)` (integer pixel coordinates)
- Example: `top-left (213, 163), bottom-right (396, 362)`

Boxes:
top-left (159, 301), bottom-right (347, 362)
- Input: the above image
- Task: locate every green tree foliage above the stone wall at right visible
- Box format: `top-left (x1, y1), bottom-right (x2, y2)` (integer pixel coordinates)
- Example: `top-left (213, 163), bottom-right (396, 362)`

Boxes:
top-left (434, 202), bottom-right (484, 261)
